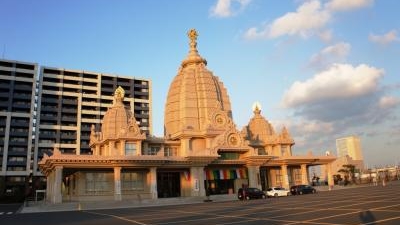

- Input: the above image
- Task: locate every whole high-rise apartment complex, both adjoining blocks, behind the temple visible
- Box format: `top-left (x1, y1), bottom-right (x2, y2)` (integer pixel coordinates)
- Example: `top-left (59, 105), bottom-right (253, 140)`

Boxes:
top-left (0, 57), bottom-right (152, 200)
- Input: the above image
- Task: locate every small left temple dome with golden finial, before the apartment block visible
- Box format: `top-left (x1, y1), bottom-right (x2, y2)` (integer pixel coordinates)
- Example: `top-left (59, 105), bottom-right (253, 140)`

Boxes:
top-left (101, 87), bottom-right (133, 139)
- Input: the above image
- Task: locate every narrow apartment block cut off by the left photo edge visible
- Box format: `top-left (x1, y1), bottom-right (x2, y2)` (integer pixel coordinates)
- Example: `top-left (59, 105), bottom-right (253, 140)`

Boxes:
top-left (0, 59), bottom-right (38, 199)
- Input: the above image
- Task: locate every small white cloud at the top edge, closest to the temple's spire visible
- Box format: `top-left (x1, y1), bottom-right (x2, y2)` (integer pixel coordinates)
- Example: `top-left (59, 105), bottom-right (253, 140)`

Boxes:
top-left (210, 0), bottom-right (251, 17)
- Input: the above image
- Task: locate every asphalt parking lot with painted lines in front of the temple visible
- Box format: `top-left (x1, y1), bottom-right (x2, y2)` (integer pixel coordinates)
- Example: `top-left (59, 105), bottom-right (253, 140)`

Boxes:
top-left (1, 181), bottom-right (400, 225)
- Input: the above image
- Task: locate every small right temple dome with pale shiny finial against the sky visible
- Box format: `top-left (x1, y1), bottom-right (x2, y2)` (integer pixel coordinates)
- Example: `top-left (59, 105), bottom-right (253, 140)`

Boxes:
top-left (245, 104), bottom-right (275, 143)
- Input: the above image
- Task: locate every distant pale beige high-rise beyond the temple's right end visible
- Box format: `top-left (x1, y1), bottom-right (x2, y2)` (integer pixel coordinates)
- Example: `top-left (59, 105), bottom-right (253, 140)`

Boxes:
top-left (336, 135), bottom-right (364, 160)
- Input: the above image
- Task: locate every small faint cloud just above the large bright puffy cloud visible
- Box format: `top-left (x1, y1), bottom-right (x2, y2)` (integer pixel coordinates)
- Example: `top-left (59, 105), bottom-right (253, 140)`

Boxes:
top-left (309, 42), bottom-right (351, 70)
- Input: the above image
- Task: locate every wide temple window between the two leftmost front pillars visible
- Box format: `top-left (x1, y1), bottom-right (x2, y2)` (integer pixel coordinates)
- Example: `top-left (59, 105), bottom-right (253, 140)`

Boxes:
top-left (85, 173), bottom-right (114, 194)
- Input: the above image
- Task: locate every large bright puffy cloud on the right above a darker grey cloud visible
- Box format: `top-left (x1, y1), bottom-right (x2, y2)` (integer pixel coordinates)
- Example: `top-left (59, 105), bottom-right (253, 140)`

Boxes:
top-left (282, 64), bottom-right (384, 107)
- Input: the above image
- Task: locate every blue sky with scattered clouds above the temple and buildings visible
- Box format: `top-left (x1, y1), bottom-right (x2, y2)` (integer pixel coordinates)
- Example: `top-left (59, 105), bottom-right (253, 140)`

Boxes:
top-left (0, 0), bottom-right (400, 168)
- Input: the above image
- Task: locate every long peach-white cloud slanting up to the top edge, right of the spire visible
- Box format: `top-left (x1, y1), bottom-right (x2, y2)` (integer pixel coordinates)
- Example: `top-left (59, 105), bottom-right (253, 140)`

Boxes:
top-left (244, 0), bottom-right (331, 39)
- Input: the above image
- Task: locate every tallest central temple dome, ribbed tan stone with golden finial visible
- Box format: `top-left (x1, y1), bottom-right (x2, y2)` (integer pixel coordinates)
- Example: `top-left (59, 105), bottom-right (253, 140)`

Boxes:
top-left (164, 29), bottom-right (232, 139)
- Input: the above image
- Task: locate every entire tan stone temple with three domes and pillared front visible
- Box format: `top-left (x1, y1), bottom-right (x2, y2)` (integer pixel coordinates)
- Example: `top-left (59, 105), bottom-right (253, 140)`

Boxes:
top-left (39, 30), bottom-right (335, 203)
